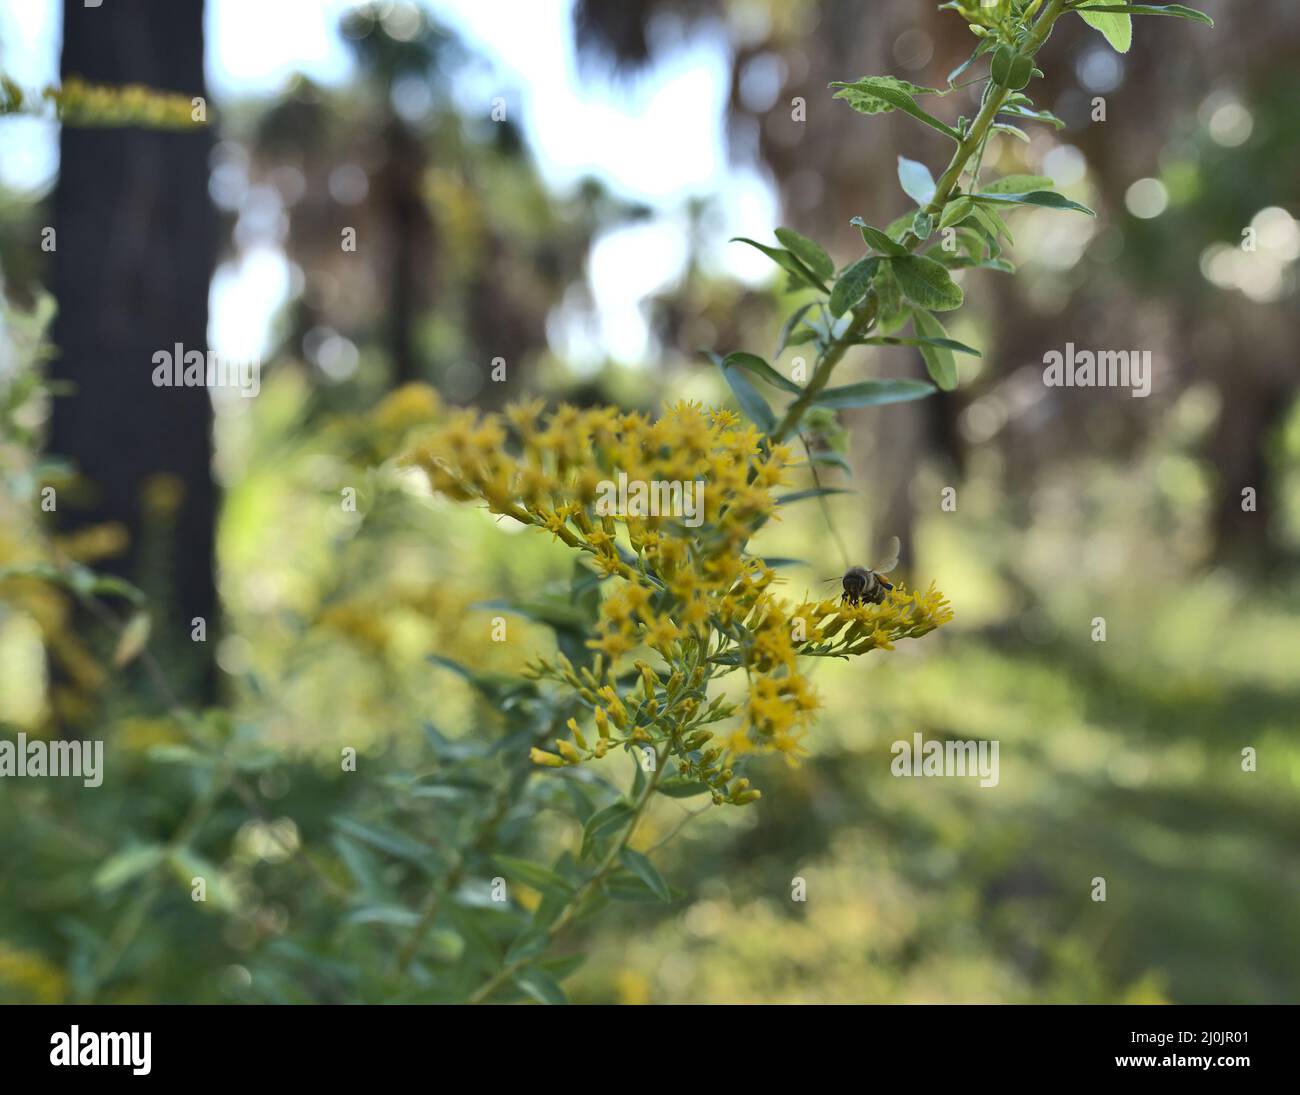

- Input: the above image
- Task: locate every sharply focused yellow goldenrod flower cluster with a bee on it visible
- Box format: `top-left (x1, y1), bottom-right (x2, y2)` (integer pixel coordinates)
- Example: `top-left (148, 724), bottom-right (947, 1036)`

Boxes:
top-left (406, 403), bottom-right (952, 804)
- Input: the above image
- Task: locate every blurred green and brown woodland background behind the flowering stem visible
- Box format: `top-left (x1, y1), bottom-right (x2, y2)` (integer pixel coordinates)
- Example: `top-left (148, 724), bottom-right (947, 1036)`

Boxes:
top-left (0, 0), bottom-right (1300, 1003)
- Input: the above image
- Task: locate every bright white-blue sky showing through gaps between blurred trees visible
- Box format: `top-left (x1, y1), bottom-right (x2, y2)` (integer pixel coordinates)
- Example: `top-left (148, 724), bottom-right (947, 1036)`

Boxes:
top-left (0, 0), bottom-right (776, 365)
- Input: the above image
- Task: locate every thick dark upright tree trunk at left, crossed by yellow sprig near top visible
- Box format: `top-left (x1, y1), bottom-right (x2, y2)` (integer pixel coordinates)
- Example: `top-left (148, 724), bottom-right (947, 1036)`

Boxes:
top-left (49, 0), bottom-right (217, 700)
